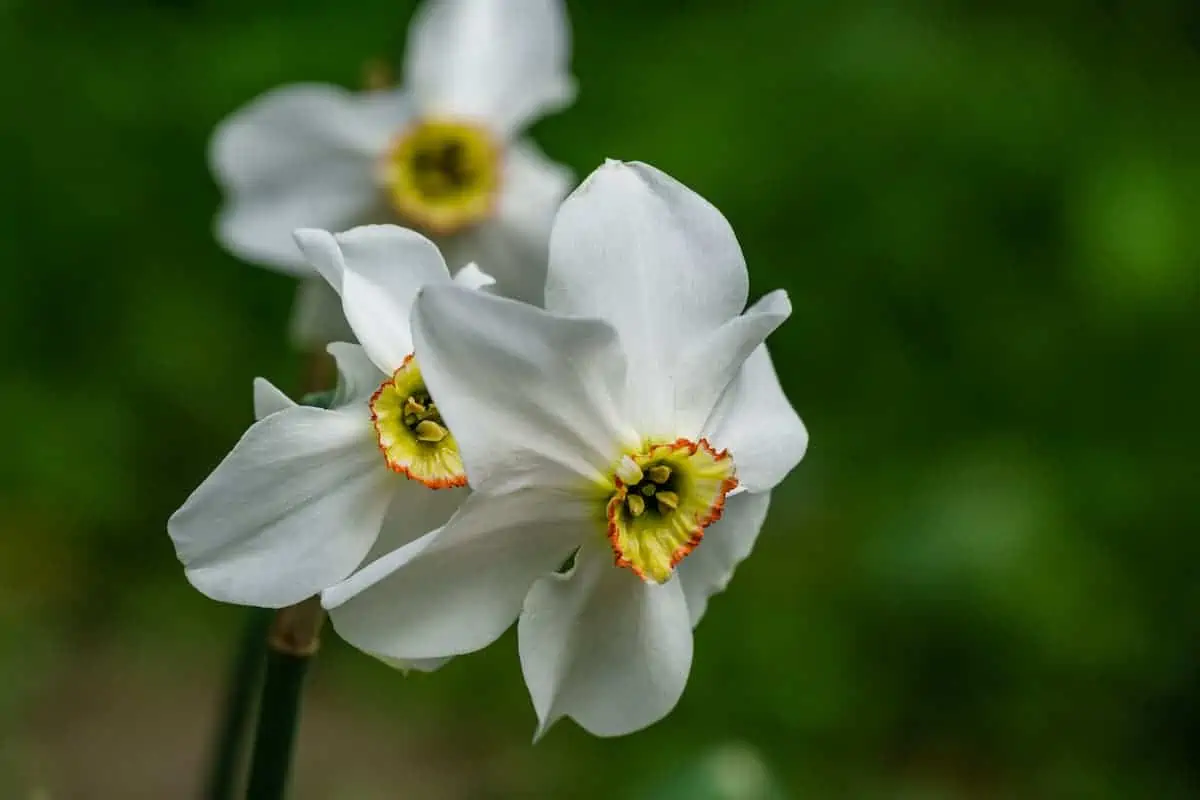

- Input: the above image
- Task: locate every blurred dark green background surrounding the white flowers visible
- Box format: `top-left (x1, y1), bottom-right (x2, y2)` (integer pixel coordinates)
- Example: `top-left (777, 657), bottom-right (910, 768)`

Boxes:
top-left (0, 0), bottom-right (1200, 800)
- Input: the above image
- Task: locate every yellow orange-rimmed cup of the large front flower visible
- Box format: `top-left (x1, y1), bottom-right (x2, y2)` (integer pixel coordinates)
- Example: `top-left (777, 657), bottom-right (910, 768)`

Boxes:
top-left (605, 439), bottom-right (738, 583)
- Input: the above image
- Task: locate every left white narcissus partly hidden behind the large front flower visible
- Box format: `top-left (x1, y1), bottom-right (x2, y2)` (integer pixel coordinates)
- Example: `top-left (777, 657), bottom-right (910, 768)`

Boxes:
top-left (167, 225), bottom-right (490, 607)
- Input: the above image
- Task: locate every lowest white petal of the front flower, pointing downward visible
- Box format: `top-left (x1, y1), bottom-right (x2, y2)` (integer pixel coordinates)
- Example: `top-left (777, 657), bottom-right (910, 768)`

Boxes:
top-left (517, 542), bottom-right (692, 736)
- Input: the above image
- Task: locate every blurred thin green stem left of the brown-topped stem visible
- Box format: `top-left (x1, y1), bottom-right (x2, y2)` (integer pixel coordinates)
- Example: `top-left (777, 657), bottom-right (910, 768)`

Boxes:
top-left (204, 608), bottom-right (271, 800)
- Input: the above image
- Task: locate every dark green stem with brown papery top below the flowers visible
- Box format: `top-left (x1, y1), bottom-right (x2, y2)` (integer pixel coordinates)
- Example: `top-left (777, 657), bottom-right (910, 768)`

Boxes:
top-left (246, 597), bottom-right (325, 800)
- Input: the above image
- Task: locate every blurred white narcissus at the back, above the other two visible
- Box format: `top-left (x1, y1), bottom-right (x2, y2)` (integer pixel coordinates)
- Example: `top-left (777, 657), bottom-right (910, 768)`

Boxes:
top-left (210, 0), bottom-right (575, 344)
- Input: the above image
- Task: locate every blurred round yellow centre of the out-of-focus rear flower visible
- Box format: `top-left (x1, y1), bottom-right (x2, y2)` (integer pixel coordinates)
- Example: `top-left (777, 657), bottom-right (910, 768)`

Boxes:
top-left (384, 119), bottom-right (500, 236)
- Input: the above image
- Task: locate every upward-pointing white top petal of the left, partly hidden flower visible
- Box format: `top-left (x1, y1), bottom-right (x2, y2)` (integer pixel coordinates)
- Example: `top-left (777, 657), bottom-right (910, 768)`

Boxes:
top-left (295, 225), bottom-right (450, 374)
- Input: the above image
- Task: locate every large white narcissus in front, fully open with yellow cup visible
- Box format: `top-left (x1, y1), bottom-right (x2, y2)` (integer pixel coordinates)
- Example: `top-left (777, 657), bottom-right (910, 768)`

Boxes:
top-left (323, 162), bottom-right (808, 735)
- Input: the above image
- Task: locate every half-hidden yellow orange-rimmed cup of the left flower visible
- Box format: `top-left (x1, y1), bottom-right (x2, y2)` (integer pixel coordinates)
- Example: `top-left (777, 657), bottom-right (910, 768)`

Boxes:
top-left (371, 355), bottom-right (467, 489)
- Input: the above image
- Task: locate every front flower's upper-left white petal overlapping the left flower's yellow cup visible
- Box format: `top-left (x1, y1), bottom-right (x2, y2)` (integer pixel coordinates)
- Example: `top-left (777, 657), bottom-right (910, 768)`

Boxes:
top-left (413, 285), bottom-right (636, 492)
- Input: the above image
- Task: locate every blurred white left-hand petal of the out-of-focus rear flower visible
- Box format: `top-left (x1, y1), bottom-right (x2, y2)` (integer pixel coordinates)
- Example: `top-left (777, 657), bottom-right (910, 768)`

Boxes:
top-left (209, 84), bottom-right (412, 275)
